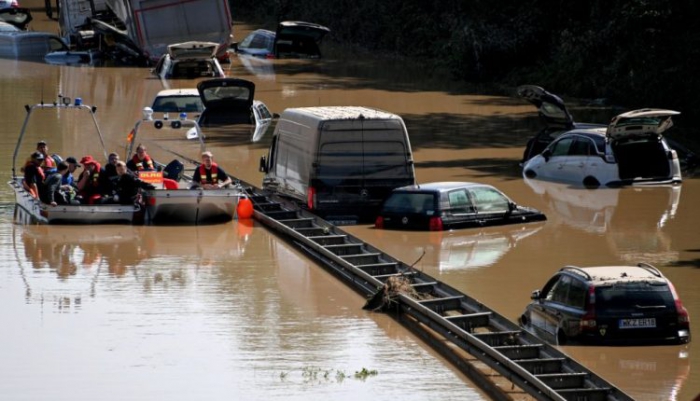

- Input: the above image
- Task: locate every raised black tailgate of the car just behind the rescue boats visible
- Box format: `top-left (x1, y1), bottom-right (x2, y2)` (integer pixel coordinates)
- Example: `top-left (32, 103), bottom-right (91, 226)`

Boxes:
top-left (197, 78), bottom-right (255, 112)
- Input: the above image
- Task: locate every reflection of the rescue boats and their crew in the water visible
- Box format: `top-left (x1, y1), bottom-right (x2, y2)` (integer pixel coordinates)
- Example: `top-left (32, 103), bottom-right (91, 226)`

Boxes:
top-left (13, 220), bottom-right (254, 309)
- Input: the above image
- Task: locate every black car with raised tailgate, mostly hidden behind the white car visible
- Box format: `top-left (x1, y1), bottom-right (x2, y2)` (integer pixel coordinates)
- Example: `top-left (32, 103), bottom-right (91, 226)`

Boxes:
top-left (517, 85), bottom-right (700, 171)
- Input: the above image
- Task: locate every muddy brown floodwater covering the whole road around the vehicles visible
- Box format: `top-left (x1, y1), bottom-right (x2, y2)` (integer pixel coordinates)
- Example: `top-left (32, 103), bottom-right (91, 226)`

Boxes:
top-left (0, 7), bottom-right (700, 400)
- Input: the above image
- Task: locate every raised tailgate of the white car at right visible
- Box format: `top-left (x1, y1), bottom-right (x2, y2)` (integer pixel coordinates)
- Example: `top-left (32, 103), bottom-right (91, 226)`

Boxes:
top-left (605, 109), bottom-right (681, 139)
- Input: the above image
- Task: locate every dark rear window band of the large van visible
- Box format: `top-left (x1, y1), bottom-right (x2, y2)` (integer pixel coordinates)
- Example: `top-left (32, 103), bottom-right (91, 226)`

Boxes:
top-left (318, 130), bottom-right (411, 179)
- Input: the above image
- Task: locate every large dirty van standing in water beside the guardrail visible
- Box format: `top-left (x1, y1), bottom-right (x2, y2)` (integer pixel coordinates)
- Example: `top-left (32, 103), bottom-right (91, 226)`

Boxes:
top-left (260, 106), bottom-right (415, 224)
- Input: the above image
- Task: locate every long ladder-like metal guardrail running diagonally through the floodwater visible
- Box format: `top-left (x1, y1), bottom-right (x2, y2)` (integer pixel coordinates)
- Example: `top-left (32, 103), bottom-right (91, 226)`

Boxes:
top-left (248, 188), bottom-right (632, 401)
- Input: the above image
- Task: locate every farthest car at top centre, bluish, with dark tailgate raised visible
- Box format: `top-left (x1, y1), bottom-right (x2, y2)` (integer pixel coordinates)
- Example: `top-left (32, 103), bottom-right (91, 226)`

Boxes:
top-left (236, 21), bottom-right (330, 58)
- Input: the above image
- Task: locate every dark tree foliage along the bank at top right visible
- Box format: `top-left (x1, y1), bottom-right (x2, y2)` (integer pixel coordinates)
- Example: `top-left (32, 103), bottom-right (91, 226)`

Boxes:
top-left (232, 0), bottom-right (700, 115)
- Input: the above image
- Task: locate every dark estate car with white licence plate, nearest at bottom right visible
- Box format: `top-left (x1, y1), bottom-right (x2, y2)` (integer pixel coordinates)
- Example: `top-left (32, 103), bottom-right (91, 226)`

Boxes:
top-left (519, 263), bottom-right (690, 345)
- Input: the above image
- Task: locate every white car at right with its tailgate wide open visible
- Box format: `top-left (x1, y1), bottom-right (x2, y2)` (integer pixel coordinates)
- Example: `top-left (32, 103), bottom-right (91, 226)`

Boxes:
top-left (523, 109), bottom-right (681, 187)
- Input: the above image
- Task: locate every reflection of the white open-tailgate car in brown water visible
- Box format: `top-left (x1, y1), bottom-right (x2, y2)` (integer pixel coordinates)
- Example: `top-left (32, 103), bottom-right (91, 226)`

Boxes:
top-left (525, 179), bottom-right (681, 265)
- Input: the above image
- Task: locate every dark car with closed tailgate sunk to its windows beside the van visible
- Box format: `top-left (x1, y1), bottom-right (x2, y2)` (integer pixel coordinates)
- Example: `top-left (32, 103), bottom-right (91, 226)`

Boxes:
top-left (374, 182), bottom-right (547, 231)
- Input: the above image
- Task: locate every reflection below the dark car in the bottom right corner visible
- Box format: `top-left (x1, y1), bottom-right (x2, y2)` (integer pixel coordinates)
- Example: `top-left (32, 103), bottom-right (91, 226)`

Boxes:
top-left (564, 346), bottom-right (690, 400)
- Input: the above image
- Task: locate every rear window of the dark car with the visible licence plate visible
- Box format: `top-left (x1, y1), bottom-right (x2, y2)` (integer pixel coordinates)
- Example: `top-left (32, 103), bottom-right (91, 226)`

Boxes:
top-left (595, 282), bottom-right (674, 312)
